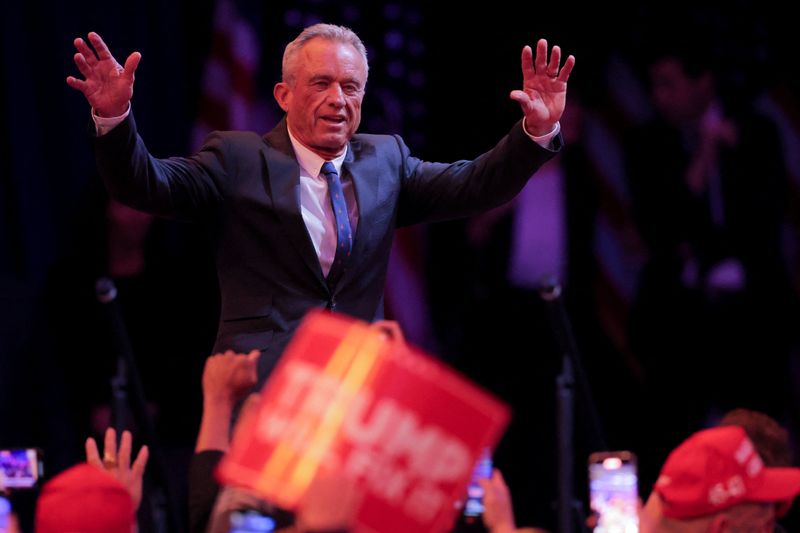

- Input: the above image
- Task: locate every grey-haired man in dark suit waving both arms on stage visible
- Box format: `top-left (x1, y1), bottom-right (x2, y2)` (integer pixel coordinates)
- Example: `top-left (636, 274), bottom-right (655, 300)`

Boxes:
top-left (67, 24), bottom-right (575, 380)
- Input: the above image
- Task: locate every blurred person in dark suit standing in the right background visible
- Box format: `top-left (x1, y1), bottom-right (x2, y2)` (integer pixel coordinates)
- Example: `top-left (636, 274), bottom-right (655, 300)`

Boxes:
top-left (625, 28), bottom-right (798, 488)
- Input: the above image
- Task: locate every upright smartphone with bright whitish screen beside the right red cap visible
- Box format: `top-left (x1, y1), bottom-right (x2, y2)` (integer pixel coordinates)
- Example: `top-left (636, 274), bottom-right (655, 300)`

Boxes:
top-left (589, 451), bottom-right (639, 533)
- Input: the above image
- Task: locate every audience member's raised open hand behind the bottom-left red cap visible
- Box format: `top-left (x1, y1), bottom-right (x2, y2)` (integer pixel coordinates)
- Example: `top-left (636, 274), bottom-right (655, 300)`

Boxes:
top-left (86, 427), bottom-right (150, 509)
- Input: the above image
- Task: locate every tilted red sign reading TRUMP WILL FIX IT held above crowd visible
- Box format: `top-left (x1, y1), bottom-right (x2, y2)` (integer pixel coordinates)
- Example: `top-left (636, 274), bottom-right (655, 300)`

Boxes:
top-left (217, 311), bottom-right (510, 533)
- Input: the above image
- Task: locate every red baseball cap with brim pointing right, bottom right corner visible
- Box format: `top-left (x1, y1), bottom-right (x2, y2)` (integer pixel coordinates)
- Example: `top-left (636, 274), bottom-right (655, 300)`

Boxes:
top-left (654, 426), bottom-right (800, 519)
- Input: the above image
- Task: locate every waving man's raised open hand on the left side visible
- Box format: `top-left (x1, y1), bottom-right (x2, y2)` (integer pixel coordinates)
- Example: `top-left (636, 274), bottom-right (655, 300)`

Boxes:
top-left (67, 32), bottom-right (142, 117)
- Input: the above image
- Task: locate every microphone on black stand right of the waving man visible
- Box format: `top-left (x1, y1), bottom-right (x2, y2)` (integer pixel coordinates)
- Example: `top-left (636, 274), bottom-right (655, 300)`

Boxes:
top-left (539, 277), bottom-right (606, 533)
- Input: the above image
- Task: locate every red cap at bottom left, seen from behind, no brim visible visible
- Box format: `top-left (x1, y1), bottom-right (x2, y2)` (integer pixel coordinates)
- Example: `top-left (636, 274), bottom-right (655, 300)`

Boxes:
top-left (35, 463), bottom-right (136, 533)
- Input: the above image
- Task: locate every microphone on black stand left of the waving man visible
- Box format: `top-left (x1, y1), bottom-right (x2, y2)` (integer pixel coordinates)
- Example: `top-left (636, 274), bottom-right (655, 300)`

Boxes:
top-left (95, 278), bottom-right (184, 533)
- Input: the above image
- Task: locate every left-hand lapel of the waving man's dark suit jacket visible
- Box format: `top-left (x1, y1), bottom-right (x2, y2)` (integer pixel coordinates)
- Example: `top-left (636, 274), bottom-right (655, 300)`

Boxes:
top-left (264, 119), bottom-right (328, 290)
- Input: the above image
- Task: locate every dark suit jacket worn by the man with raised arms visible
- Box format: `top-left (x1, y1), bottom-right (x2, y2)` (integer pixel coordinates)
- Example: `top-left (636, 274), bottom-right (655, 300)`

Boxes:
top-left (95, 116), bottom-right (562, 380)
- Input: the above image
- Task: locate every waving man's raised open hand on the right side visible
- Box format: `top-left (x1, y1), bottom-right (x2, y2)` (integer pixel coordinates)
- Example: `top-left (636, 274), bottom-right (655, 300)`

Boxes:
top-left (510, 39), bottom-right (575, 136)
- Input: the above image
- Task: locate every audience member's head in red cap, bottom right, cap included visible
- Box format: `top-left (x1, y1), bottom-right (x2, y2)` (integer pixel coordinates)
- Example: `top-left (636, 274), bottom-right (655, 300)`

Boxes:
top-left (641, 426), bottom-right (800, 533)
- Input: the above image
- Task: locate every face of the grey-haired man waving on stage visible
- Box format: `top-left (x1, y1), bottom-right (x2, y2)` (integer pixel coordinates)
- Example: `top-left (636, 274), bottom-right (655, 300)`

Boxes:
top-left (274, 38), bottom-right (367, 159)
